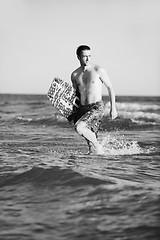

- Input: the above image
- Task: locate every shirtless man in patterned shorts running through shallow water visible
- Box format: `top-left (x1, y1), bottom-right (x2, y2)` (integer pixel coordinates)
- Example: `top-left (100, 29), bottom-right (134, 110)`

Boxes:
top-left (71, 45), bottom-right (117, 154)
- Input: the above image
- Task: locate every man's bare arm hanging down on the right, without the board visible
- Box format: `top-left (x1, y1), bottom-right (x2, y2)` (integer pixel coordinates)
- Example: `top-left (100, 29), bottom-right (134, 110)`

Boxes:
top-left (98, 68), bottom-right (117, 119)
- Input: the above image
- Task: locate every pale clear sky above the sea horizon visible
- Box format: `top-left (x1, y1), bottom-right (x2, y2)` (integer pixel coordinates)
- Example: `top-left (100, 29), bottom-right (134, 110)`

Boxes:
top-left (0, 0), bottom-right (160, 96)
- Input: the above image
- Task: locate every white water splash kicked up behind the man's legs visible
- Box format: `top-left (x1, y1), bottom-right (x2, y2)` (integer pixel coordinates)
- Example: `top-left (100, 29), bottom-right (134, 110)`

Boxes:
top-left (101, 135), bottom-right (142, 155)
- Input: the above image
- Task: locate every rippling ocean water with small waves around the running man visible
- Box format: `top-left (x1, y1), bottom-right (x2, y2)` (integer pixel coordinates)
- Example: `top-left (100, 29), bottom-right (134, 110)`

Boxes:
top-left (0, 94), bottom-right (160, 240)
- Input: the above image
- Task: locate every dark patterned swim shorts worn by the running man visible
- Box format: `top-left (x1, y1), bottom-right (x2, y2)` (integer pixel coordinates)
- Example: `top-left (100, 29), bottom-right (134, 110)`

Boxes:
top-left (69, 101), bottom-right (104, 133)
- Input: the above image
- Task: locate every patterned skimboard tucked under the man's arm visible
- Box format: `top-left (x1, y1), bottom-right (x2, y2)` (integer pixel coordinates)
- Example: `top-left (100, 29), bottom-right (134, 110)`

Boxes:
top-left (47, 78), bottom-right (79, 119)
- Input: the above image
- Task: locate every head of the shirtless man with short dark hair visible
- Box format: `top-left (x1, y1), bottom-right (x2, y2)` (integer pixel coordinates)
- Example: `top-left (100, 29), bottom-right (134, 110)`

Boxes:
top-left (76, 45), bottom-right (91, 66)
